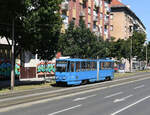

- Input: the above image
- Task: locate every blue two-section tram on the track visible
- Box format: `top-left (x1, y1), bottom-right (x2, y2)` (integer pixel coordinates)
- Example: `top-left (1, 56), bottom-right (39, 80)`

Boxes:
top-left (55, 58), bottom-right (114, 85)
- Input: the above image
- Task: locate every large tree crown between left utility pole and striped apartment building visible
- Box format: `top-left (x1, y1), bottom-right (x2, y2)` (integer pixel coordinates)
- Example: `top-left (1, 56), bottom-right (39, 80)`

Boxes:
top-left (23, 0), bottom-right (62, 59)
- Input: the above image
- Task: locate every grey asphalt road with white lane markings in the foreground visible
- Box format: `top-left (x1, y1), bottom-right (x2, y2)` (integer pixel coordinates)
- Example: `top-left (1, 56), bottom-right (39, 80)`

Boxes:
top-left (0, 72), bottom-right (150, 115)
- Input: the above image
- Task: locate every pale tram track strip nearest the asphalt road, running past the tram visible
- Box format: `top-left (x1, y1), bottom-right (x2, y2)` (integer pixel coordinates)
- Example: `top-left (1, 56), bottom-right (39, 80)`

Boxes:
top-left (0, 74), bottom-right (150, 109)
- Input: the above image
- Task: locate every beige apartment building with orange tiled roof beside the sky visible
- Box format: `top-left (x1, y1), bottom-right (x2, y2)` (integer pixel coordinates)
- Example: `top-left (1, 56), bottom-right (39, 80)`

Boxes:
top-left (110, 0), bottom-right (146, 41)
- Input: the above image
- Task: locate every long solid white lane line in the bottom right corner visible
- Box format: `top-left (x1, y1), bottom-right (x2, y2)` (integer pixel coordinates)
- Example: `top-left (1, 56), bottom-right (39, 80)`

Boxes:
top-left (111, 95), bottom-right (150, 115)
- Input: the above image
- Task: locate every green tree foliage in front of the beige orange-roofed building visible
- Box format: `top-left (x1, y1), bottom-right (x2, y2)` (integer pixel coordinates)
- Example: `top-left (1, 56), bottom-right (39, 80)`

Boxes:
top-left (109, 32), bottom-right (146, 60)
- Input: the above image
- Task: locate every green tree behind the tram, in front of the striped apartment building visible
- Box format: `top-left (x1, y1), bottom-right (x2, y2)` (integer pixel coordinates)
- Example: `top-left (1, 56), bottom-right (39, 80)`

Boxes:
top-left (59, 19), bottom-right (101, 58)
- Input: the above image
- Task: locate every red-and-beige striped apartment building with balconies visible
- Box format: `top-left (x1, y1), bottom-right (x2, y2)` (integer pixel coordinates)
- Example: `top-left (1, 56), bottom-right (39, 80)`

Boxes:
top-left (61, 0), bottom-right (111, 40)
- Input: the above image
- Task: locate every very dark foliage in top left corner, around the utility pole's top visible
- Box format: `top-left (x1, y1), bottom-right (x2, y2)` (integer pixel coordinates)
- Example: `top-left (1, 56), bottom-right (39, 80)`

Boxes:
top-left (0, 0), bottom-right (25, 39)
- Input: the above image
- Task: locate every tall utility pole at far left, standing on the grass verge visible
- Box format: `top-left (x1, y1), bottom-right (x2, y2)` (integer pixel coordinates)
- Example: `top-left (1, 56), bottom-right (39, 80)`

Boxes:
top-left (11, 16), bottom-right (15, 90)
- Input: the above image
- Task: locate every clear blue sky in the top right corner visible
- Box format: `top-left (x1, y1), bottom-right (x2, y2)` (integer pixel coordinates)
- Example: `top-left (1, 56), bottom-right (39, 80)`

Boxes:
top-left (122, 0), bottom-right (150, 41)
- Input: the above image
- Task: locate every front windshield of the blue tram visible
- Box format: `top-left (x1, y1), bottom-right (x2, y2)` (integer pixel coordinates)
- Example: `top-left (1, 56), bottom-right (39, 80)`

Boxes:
top-left (56, 61), bottom-right (67, 72)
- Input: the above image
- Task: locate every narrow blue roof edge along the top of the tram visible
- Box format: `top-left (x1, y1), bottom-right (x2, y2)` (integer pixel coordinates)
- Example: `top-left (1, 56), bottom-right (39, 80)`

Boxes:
top-left (57, 58), bottom-right (113, 62)
